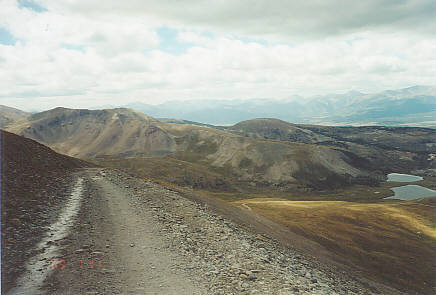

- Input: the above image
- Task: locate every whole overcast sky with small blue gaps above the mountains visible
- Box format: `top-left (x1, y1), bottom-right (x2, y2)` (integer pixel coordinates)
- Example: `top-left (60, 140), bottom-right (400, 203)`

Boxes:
top-left (0, 0), bottom-right (436, 110)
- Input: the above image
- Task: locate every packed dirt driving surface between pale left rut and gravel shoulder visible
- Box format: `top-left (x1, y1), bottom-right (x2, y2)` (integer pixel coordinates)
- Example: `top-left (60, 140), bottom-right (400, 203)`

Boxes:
top-left (29, 169), bottom-right (204, 294)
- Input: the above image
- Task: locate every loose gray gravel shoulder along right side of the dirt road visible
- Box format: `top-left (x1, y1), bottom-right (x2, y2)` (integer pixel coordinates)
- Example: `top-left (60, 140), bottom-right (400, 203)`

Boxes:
top-left (106, 172), bottom-right (392, 294)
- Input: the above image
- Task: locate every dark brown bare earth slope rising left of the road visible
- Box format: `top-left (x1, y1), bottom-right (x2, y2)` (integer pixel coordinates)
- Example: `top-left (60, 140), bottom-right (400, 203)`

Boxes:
top-left (0, 130), bottom-right (91, 291)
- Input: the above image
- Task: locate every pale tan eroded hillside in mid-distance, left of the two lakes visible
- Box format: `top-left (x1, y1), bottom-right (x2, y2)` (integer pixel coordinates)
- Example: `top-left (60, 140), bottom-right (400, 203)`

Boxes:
top-left (162, 124), bottom-right (364, 185)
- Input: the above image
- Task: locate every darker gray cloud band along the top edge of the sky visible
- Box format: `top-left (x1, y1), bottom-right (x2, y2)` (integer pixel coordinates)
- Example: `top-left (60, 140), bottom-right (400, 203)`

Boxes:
top-left (36, 0), bottom-right (436, 39)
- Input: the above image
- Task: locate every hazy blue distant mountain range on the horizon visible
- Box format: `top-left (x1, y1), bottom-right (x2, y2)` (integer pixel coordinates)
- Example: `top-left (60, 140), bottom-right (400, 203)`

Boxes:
top-left (123, 86), bottom-right (436, 128)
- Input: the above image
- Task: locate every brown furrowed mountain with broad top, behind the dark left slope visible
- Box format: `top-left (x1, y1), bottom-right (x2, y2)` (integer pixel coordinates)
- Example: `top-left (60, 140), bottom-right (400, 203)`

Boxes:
top-left (5, 108), bottom-right (175, 158)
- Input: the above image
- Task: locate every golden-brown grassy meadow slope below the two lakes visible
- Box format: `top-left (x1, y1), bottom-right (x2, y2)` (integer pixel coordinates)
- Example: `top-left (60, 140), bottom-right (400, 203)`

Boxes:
top-left (234, 198), bottom-right (436, 294)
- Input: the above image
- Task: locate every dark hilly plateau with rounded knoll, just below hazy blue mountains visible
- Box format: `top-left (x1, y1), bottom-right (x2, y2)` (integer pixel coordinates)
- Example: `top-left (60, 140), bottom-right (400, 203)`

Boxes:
top-left (227, 119), bottom-right (436, 177)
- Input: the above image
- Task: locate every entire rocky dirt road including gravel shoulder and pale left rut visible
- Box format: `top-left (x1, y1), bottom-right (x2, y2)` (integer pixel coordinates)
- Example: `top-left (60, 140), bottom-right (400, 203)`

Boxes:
top-left (9, 169), bottom-right (398, 294)
